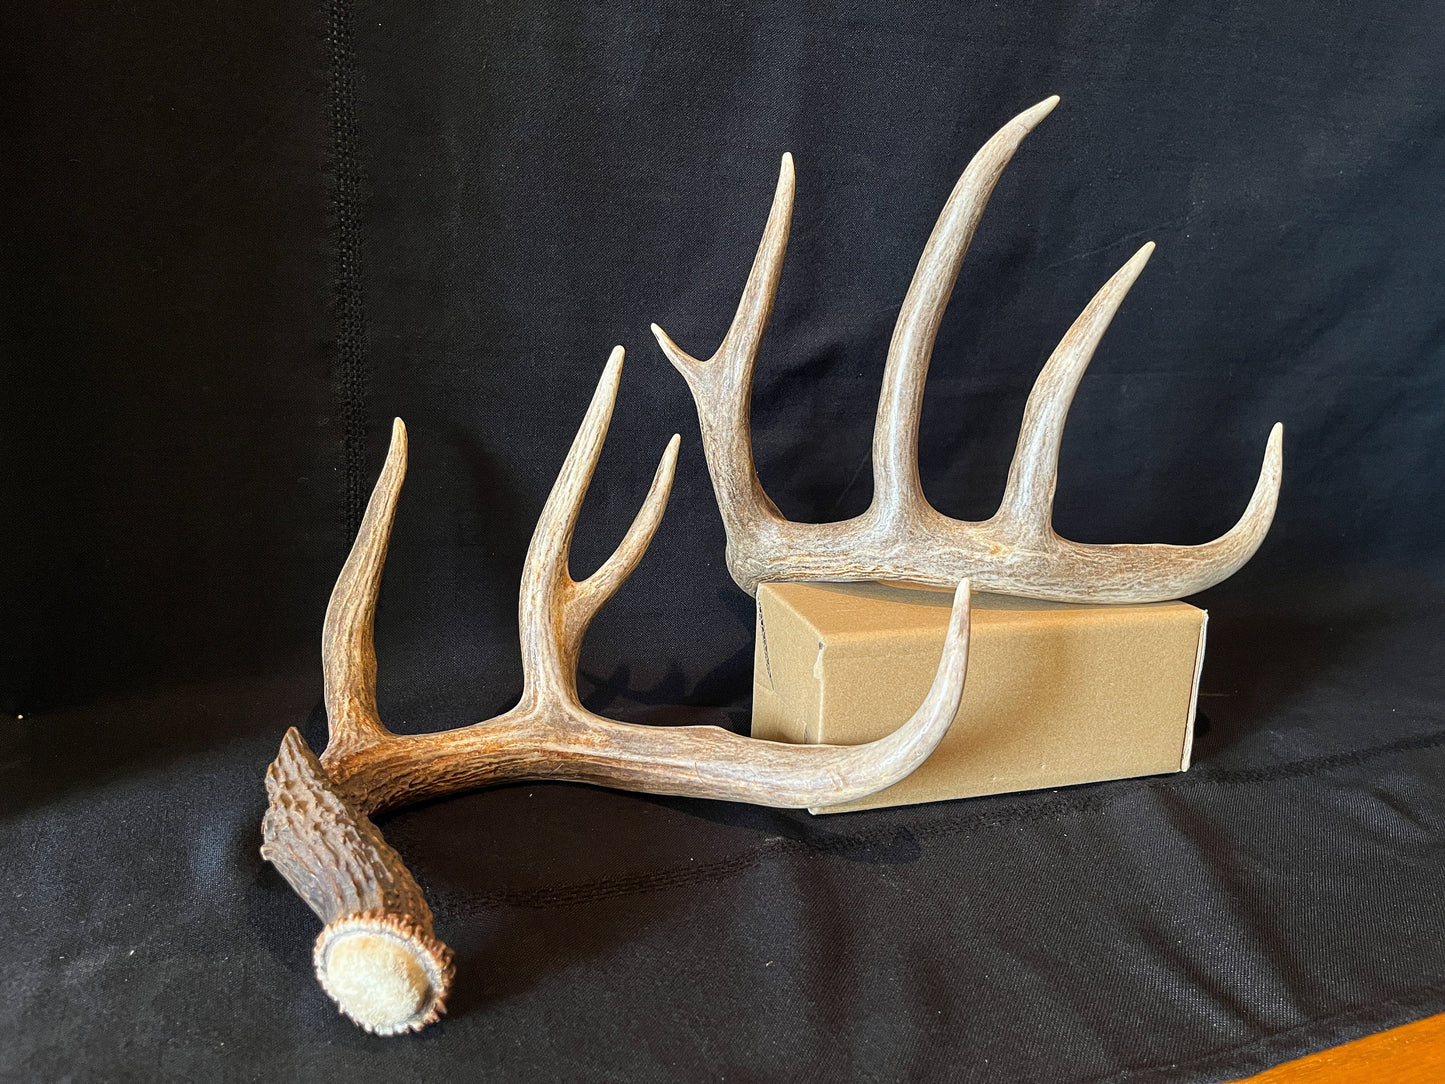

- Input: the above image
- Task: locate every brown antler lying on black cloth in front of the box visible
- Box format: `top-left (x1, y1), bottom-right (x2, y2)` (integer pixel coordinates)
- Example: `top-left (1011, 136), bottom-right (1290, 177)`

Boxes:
top-left (262, 347), bottom-right (968, 1035)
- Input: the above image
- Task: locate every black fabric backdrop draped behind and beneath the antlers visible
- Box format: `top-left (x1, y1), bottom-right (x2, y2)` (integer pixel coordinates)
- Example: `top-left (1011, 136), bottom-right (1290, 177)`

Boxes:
top-left (0, 0), bottom-right (1445, 1081)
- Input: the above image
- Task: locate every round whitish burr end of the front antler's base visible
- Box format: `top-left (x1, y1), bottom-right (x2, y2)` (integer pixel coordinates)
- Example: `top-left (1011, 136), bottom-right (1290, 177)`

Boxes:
top-left (312, 911), bottom-right (452, 1035)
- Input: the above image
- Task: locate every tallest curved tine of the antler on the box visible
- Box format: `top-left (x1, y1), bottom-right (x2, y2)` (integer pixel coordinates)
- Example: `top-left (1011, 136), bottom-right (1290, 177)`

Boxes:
top-left (873, 94), bottom-right (1059, 523)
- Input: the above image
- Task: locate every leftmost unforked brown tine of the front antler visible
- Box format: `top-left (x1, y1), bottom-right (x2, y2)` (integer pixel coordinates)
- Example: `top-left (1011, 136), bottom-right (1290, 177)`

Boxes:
top-left (321, 418), bottom-right (406, 757)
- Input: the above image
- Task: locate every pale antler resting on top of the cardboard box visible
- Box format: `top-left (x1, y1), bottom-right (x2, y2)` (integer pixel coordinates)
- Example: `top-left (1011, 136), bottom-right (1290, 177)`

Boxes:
top-left (652, 97), bottom-right (1283, 603)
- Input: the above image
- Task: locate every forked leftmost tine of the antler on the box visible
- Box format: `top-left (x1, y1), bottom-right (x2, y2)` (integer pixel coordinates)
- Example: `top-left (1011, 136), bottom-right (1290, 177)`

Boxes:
top-left (652, 155), bottom-right (795, 541)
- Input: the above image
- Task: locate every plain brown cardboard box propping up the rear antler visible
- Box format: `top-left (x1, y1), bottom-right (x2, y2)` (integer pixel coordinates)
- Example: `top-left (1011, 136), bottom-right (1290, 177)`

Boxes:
top-left (753, 582), bottom-right (1208, 812)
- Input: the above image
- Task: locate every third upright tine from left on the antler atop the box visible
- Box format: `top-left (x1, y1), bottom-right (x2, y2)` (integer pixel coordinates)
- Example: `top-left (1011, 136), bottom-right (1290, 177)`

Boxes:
top-left (993, 241), bottom-right (1155, 545)
